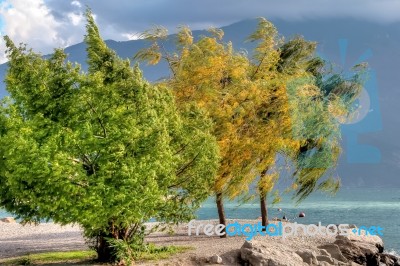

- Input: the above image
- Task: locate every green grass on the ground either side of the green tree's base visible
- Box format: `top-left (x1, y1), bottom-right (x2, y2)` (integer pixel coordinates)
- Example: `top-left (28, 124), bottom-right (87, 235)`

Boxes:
top-left (0, 245), bottom-right (193, 265)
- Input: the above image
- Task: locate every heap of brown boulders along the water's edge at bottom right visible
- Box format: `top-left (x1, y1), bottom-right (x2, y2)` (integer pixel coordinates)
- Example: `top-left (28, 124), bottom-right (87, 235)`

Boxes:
top-left (236, 231), bottom-right (390, 266)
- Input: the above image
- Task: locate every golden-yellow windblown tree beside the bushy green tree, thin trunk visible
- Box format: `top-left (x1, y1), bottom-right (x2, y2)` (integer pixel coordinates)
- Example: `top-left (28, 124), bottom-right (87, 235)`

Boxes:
top-left (136, 20), bottom-right (287, 234)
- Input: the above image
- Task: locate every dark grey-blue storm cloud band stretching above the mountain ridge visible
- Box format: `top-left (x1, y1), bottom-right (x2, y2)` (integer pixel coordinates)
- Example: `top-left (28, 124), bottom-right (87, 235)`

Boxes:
top-left (47, 0), bottom-right (400, 37)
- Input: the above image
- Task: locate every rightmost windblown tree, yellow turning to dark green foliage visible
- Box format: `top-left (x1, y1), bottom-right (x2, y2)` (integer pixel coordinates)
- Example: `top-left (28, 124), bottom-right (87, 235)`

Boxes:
top-left (249, 29), bottom-right (364, 225)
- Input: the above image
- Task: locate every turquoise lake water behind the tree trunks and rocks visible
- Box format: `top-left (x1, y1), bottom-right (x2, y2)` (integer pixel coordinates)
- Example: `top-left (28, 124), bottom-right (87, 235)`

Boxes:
top-left (0, 188), bottom-right (400, 254)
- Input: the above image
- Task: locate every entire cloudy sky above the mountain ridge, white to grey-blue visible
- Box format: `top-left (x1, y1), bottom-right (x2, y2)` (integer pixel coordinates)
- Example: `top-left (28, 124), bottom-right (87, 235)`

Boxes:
top-left (0, 0), bottom-right (400, 63)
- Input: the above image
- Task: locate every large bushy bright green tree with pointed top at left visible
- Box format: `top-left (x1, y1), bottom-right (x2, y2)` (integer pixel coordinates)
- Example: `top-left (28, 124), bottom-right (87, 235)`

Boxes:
top-left (0, 11), bottom-right (219, 261)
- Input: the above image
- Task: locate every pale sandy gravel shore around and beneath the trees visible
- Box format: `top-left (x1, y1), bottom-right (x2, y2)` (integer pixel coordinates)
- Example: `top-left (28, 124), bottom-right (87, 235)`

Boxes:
top-left (0, 220), bottom-right (332, 265)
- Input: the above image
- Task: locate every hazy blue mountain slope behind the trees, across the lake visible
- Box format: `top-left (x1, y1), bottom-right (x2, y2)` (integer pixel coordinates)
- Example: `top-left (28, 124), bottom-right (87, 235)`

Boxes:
top-left (0, 19), bottom-right (400, 187)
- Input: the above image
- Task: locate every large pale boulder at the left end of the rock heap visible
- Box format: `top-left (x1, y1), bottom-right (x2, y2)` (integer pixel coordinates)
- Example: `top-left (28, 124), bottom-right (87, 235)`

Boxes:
top-left (240, 240), bottom-right (308, 266)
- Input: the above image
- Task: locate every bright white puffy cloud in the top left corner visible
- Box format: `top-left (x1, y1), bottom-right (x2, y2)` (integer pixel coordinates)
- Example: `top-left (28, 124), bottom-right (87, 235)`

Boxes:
top-left (0, 0), bottom-right (84, 63)
